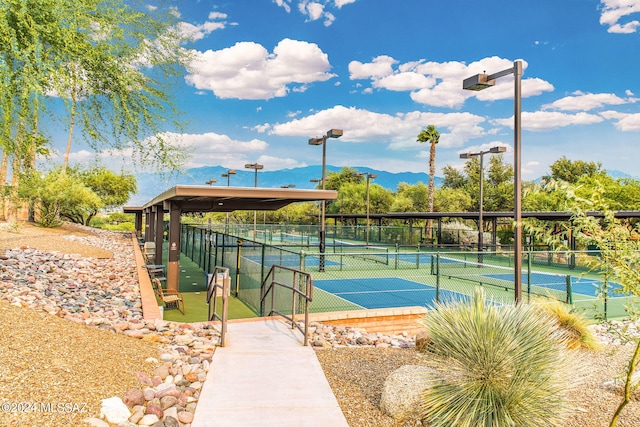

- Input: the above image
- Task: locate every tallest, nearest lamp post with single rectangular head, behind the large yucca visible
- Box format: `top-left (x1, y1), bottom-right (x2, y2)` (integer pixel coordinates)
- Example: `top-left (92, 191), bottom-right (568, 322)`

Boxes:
top-left (462, 61), bottom-right (522, 304)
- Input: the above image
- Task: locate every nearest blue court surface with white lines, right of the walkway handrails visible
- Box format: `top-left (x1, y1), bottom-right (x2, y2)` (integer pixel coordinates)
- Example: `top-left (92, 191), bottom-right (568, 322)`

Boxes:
top-left (313, 277), bottom-right (469, 309)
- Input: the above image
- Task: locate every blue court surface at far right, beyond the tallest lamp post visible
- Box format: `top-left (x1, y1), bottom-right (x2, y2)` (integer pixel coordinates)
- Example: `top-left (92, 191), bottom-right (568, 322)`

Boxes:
top-left (486, 272), bottom-right (624, 298)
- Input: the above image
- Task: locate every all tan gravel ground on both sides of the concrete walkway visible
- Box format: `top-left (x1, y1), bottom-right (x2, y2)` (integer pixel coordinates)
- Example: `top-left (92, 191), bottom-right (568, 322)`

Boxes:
top-left (0, 224), bottom-right (640, 427)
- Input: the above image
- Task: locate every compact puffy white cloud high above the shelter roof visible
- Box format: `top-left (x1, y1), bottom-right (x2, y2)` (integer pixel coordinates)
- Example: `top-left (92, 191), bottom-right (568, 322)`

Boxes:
top-left (185, 39), bottom-right (335, 99)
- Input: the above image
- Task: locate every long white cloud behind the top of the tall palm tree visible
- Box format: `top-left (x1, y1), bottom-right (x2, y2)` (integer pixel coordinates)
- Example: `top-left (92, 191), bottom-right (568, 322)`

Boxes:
top-left (269, 105), bottom-right (484, 150)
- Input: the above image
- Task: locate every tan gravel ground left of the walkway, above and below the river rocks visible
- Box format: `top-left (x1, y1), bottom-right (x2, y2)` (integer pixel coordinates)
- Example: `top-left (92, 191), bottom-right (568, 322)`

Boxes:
top-left (0, 224), bottom-right (160, 427)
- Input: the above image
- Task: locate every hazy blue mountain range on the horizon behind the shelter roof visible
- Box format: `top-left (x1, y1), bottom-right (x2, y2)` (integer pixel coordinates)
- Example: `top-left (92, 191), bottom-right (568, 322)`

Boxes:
top-left (127, 165), bottom-right (442, 206)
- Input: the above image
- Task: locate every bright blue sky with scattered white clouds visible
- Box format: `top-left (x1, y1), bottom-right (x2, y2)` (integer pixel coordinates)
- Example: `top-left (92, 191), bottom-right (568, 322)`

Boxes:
top-left (56, 0), bottom-right (640, 180)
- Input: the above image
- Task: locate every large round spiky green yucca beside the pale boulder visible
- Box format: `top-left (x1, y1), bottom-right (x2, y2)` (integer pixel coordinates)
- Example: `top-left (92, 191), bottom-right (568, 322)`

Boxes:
top-left (422, 288), bottom-right (577, 427)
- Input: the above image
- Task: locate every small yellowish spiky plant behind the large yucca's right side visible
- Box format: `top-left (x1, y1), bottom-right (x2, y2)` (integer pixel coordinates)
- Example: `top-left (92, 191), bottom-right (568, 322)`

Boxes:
top-left (534, 298), bottom-right (600, 350)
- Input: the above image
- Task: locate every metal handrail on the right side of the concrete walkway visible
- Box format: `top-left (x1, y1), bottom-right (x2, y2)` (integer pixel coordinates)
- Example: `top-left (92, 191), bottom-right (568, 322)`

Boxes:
top-left (260, 265), bottom-right (313, 346)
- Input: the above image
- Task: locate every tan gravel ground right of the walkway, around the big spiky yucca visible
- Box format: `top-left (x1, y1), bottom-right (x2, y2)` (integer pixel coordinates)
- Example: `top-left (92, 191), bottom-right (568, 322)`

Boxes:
top-left (317, 332), bottom-right (640, 427)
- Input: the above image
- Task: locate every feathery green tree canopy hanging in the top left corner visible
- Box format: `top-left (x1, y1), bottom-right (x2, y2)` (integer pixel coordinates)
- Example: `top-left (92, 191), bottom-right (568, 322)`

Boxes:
top-left (0, 0), bottom-right (186, 184)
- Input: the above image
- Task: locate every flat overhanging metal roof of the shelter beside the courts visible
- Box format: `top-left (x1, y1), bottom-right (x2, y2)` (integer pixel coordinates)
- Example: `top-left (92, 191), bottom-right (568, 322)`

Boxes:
top-left (124, 185), bottom-right (338, 213)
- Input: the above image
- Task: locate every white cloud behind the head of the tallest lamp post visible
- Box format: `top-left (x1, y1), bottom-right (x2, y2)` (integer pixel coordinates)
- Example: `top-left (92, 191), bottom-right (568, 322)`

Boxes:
top-left (349, 56), bottom-right (554, 108)
